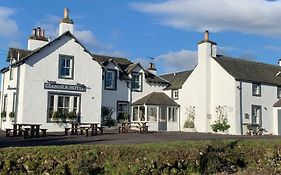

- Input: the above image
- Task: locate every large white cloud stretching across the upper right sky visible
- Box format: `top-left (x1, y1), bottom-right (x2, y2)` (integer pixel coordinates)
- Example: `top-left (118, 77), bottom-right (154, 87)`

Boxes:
top-left (131, 0), bottom-right (281, 36)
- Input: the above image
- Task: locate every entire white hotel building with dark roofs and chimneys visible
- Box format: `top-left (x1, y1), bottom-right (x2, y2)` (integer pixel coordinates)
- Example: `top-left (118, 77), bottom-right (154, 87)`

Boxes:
top-left (0, 9), bottom-right (281, 135)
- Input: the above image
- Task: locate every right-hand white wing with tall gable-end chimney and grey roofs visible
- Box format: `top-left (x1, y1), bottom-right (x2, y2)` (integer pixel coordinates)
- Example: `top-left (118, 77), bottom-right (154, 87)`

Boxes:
top-left (161, 31), bottom-right (281, 135)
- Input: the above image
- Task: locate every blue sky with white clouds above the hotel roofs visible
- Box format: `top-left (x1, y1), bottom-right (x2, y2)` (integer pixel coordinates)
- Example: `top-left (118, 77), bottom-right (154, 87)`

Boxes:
top-left (0, 0), bottom-right (281, 74)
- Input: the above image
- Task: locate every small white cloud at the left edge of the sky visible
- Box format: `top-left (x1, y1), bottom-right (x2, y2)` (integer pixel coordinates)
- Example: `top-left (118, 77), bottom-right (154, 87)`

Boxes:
top-left (0, 7), bottom-right (19, 37)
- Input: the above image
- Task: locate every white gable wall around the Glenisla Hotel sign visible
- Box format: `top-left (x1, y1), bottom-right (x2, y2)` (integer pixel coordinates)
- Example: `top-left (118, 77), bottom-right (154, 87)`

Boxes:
top-left (7, 36), bottom-right (102, 131)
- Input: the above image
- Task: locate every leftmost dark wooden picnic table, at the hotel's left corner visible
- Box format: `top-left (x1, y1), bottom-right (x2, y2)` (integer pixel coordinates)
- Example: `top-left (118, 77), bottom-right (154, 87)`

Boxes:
top-left (13, 123), bottom-right (42, 138)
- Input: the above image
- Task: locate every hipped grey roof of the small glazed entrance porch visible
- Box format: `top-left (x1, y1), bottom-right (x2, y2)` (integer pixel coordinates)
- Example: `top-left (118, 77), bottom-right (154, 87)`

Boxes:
top-left (133, 92), bottom-right (179, 106)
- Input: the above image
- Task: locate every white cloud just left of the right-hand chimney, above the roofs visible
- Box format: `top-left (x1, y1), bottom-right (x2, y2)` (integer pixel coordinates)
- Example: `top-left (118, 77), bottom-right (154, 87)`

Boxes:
top-left (155, 49), bottom-right (197, 73)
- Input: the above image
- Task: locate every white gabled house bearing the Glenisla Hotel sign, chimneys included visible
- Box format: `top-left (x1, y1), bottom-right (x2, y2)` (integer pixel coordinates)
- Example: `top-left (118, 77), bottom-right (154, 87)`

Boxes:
top-left (0, 9), bottom-right (103, 131)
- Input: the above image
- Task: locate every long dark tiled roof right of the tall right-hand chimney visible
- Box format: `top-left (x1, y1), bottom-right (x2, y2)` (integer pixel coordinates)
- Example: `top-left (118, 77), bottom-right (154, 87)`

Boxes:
top-left (215, 56), bottom-right (281, 86)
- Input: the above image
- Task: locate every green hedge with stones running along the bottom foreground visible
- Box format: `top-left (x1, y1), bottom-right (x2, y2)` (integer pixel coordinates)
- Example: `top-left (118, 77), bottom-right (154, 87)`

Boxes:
top-left (0, 139), bottom-right (281, 175)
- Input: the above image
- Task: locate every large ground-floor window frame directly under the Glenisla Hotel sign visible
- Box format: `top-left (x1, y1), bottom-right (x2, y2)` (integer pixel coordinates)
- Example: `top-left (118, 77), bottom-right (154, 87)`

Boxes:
top-left (47, 91), bottom-right (82, 123)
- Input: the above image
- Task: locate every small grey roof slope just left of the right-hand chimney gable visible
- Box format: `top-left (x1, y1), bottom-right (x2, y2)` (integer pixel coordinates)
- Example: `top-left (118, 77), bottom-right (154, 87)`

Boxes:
top-left (160, 70), bottom-right (193, 90)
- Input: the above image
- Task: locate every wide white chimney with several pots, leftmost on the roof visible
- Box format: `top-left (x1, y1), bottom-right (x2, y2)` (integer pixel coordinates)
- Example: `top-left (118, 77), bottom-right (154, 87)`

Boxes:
top-left (27, 27), bottom-right (49, 50)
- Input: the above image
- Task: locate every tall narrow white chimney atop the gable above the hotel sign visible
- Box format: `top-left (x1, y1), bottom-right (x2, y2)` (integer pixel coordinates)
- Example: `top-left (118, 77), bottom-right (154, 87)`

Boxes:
top-left (59, 8), bottom-right (73, 36)
